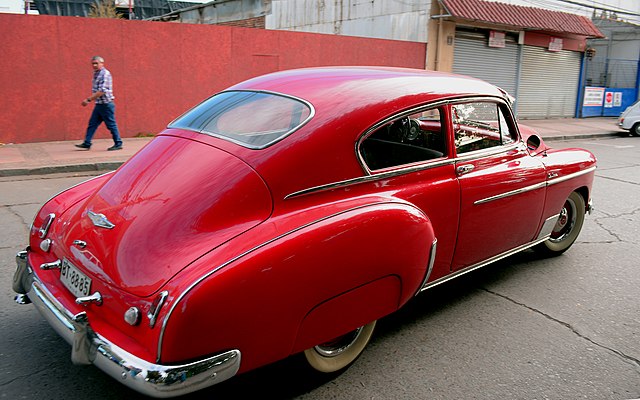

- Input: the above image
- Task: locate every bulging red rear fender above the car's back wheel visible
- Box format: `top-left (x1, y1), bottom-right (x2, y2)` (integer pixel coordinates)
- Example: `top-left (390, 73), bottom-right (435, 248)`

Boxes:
top-left (160, 202), bottom-right (434, 372)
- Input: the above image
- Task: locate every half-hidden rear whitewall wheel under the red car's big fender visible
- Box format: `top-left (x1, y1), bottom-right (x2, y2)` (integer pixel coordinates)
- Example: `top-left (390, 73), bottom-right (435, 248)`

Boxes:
top-left (304, 321), bottom-right (376, 373)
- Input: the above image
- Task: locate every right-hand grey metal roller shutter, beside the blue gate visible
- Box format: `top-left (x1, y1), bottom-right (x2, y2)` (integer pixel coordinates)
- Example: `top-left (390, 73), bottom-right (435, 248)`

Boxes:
top-left (518, 46), bottom-right (582, 118)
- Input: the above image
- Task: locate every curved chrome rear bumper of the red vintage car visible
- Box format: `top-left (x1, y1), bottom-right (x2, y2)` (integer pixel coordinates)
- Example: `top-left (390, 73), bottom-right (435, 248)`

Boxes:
top-left (13, 251), bottom-right (241, 397)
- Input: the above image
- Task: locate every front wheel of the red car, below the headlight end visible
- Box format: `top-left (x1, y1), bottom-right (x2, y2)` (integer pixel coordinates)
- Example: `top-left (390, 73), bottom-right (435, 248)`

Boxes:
top-left (535, 192), bottom-right (586, 256)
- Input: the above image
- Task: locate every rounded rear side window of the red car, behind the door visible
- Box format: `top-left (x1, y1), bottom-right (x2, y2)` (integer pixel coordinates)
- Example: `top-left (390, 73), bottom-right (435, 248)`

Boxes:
top-left (359, 108), bottom-right (447, 171)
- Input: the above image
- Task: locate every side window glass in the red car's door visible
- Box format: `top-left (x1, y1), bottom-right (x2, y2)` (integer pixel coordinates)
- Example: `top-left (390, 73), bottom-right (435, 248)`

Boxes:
top-left (451, 102), bottom-right (515, 154)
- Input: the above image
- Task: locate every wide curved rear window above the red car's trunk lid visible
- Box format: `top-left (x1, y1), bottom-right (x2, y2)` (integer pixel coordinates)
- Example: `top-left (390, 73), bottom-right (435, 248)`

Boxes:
top-left (169, 91), bottom-right (312, 149)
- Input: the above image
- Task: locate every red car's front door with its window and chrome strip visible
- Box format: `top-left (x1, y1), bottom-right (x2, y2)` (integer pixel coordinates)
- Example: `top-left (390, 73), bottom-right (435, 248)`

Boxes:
top-left (450, 99), bottom-right (546, 271)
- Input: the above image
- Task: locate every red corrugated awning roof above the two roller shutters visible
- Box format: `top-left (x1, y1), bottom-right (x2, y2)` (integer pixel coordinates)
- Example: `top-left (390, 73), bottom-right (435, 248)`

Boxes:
top-left (440, 0), bottom-right (604, 37)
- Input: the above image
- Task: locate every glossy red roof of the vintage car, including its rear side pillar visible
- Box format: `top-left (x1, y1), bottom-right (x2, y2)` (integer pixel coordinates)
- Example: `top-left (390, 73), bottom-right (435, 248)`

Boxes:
top-left (195, 67), bottom-right (504, 202)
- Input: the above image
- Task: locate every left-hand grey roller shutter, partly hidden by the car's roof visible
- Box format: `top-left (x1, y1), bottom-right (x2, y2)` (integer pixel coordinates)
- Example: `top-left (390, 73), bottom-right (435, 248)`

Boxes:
top-left (453, 32), bottom-right (518, 96)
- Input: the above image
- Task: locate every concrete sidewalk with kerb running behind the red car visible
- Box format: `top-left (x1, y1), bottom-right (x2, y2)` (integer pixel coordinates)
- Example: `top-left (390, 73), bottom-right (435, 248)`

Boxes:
top-left (0, 118), bottom-right (626, 177)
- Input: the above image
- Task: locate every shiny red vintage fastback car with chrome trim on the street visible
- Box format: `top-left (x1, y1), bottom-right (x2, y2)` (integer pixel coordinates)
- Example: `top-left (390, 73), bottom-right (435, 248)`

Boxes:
top-left (13, 67), bottom-right (596, 397)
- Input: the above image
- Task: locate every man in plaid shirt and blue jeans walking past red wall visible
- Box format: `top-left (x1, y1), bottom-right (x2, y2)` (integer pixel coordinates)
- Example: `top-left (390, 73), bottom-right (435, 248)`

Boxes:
top-left (76, 56), bottom-right (122, 150)
